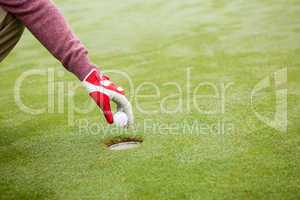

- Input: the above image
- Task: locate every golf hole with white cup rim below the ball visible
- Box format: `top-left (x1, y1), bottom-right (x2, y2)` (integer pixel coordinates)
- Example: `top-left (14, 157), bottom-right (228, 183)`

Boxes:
top-left (106, 137), bottom-right (143, 151)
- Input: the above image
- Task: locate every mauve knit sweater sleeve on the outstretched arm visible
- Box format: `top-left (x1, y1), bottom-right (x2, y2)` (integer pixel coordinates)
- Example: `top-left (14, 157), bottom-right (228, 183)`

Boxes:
top-left (0, 0), bottom-right (94, 80)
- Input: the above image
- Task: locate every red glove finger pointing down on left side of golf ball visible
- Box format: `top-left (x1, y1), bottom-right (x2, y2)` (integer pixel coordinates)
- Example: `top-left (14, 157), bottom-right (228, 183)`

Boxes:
top-left (90, 92), bottom-right (114, 124)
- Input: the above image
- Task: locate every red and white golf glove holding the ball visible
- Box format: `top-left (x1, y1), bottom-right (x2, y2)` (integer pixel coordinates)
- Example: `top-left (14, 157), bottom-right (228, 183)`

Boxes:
top-left (83, 69), bottom-right (134, 126)
